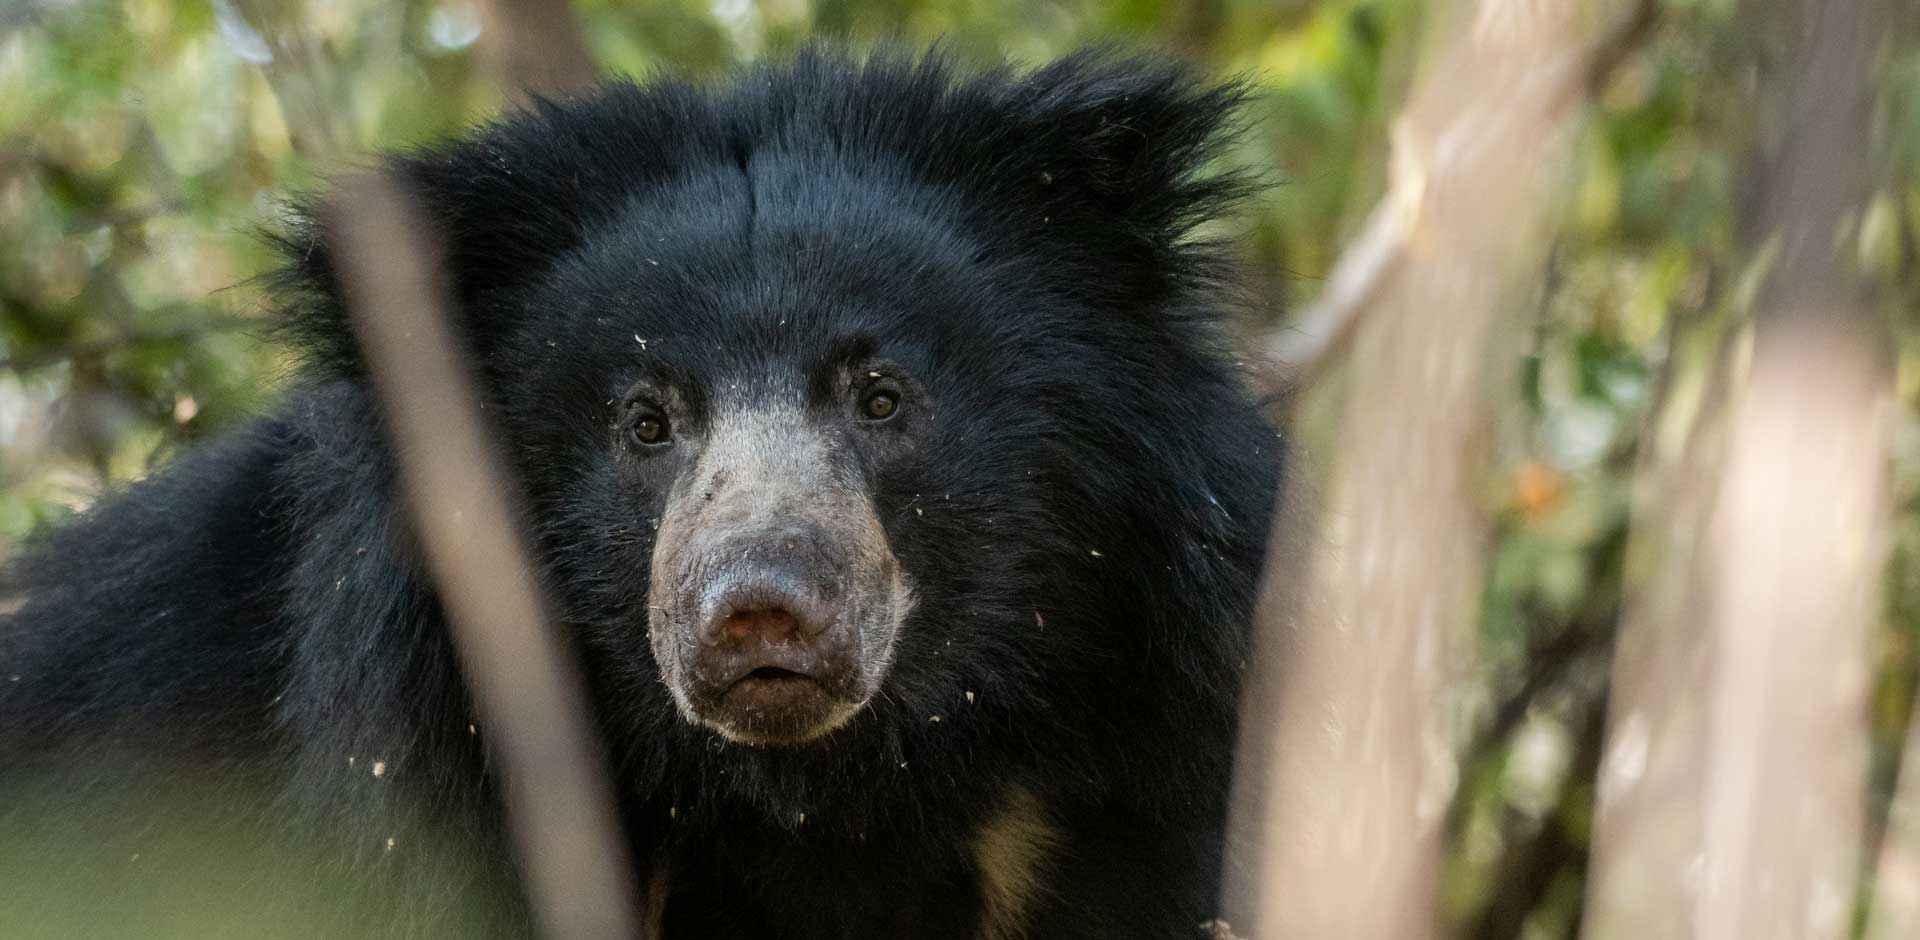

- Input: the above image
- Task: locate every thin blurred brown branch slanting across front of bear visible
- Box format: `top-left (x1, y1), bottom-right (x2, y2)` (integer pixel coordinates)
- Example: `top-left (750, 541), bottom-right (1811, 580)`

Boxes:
top-left (320, 176), bottom-right (641, 940)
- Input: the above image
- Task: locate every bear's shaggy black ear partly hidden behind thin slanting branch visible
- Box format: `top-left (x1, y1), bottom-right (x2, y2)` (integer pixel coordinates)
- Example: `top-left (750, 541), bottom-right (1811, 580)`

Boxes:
top-left (265, 81), bottom-right (697, 374)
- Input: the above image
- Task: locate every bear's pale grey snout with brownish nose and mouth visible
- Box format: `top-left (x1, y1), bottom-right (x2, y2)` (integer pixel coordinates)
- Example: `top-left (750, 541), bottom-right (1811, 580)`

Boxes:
top-left (649, 411), bottom-right (912, 744)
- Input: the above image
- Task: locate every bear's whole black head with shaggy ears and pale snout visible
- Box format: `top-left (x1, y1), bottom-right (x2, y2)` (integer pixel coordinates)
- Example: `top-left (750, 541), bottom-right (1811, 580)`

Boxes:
top-left (270, 52), bottom-right (1277, 809)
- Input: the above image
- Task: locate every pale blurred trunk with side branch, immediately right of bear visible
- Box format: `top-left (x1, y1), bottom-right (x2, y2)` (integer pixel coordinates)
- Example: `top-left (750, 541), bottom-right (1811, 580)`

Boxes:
top-left (1225, 0), bottom-right (1651, 940)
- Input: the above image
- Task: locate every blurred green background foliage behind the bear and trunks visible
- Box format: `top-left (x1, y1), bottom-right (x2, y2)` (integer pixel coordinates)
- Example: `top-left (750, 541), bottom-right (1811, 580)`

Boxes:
top-left (0, 0), bottom-right (1920, 938)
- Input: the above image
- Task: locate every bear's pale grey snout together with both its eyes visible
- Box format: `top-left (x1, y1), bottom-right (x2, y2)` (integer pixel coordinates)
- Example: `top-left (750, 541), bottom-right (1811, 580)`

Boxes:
top-left (612, 347), bottom-right (929, 744)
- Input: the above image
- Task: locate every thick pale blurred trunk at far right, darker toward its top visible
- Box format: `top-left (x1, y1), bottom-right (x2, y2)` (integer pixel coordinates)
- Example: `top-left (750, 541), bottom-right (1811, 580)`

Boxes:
top-left (1586, 0), bottom-right (1893, 940)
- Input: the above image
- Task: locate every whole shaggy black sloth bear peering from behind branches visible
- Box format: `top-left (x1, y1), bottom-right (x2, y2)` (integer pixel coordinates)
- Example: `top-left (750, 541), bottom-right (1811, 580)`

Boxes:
top-left (11, 50), bottom-right (1281, 940)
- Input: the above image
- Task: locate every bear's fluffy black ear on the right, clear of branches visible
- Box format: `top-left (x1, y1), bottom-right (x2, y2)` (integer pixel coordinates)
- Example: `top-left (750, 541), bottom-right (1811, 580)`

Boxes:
top-left (985, 50), bottom-right (1258, 270)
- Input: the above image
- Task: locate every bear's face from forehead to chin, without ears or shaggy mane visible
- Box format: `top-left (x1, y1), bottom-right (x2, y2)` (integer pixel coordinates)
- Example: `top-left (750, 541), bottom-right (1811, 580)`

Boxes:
top-left (493, 157), bottom-right (1062, 746)
